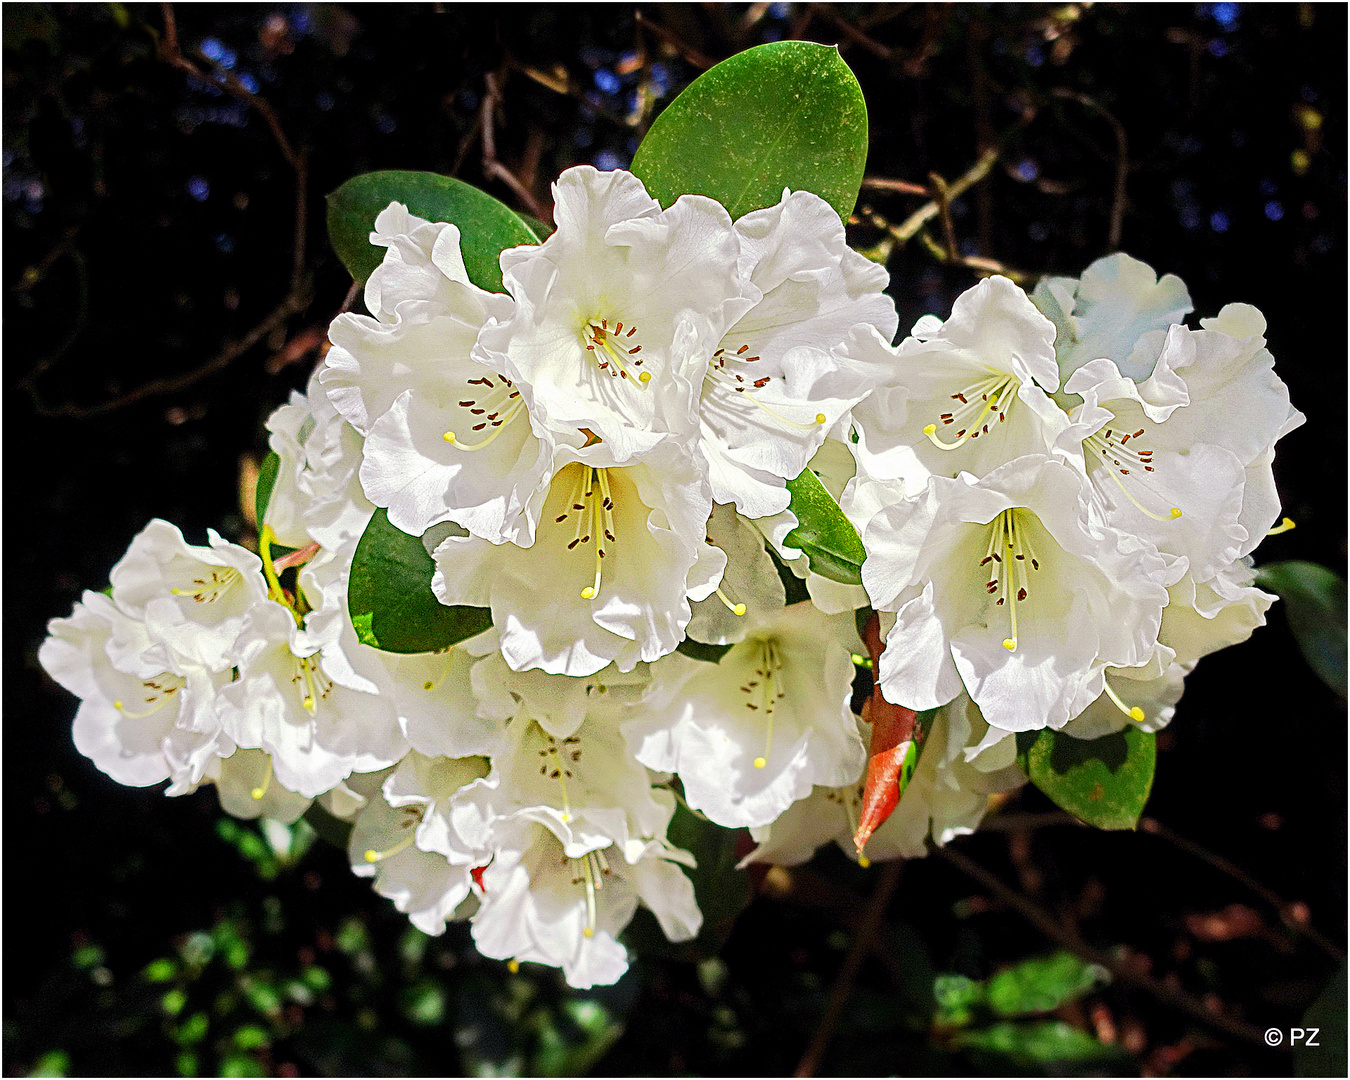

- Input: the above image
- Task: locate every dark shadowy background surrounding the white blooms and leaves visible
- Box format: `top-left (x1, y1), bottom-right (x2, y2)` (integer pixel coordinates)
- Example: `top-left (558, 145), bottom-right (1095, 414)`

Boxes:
top-left (3, 4), bottom-right (1346, 1075)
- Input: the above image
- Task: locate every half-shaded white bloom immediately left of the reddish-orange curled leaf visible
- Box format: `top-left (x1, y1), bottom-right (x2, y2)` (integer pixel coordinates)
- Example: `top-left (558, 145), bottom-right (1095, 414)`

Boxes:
top-left (624, 603), bottom-right (865, 828)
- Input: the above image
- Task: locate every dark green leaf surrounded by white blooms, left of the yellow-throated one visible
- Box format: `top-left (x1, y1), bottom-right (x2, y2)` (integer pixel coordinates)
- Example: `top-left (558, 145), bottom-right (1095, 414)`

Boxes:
top-left (347, 510), bottom-right (493, 652)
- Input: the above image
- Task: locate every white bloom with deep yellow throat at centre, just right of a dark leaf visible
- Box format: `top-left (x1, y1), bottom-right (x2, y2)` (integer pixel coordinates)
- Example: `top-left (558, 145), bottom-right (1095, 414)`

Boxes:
top-left (432, 441), bottom-right (726, 675)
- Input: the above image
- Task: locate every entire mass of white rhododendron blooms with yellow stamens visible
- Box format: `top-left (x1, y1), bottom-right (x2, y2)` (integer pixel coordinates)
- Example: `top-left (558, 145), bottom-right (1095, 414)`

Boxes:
top-left (41, 167), bottom-right (1301, 987)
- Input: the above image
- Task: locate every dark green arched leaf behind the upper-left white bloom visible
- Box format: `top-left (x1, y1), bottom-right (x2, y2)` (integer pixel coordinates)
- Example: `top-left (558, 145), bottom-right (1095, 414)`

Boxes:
top-left (328, 169), bottom-right (540, 293)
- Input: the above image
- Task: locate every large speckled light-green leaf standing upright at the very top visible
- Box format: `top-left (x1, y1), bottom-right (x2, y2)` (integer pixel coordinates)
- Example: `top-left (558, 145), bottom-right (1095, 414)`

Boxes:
top-left (633, 41), bottom-right (867, 221)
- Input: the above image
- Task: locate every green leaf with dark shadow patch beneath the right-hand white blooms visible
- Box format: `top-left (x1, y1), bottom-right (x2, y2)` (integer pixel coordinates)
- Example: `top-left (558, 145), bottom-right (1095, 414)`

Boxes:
top-left (1017, 725), bottom-right (1157, 829)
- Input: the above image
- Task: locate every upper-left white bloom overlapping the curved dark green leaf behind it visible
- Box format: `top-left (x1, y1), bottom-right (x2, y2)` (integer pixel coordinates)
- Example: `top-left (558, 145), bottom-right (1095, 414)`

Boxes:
top-left (319, 203), bottom-right (552, 543)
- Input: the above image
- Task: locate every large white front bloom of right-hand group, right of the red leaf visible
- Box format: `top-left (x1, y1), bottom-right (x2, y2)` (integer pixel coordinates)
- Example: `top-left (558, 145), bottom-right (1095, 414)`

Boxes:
top-left (857, 455), bottom-right (1175, 732)
